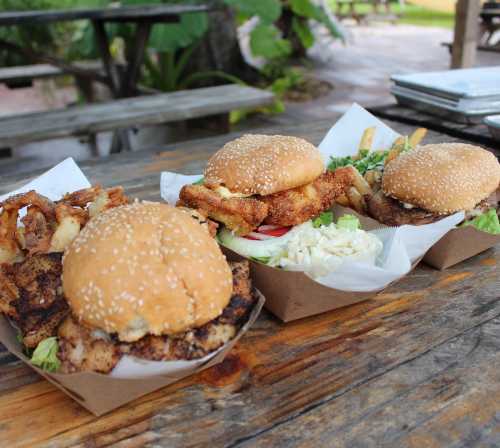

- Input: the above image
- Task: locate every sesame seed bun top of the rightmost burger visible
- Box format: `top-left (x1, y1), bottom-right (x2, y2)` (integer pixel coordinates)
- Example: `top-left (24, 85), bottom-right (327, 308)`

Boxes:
top-left (382, 143), bottom-right (500, 214)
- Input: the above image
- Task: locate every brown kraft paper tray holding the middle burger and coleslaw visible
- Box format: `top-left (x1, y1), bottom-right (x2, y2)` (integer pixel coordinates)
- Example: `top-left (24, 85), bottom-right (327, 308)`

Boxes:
top-left (222, 205), bottom-right (420, 322)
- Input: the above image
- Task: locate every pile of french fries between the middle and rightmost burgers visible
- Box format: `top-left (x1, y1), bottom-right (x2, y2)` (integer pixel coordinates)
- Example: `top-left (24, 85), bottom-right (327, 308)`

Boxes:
top-left (336, 127), bottom-right (427, 215)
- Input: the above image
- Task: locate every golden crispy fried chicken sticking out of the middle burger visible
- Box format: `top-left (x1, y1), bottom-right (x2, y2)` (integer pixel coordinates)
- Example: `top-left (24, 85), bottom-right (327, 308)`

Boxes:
top-left (179, 168), bottom-right (353, 235)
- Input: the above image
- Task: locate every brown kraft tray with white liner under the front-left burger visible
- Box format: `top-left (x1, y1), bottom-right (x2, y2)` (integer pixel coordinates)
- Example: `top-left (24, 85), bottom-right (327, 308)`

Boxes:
top-left (0, 158), bottom-right (264, 416)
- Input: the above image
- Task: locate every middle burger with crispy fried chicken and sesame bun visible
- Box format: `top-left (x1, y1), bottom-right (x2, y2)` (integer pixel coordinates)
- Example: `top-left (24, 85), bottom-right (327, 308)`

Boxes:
top-left (179, 134), bottom-right (353, 239)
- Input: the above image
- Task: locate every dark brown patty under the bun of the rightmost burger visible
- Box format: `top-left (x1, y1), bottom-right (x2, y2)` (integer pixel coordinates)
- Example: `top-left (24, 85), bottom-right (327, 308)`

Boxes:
top-left (367, 190), bottom-right (446, 226)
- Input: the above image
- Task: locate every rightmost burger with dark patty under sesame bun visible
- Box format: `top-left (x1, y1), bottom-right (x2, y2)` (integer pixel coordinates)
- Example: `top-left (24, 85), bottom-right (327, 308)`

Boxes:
top-left (367, 143), bottom-right (500, 228)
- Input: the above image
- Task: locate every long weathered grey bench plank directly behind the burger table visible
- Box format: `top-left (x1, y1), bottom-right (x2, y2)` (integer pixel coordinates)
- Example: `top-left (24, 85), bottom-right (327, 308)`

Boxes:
top-left (0, 84), bottom-right (274, 154)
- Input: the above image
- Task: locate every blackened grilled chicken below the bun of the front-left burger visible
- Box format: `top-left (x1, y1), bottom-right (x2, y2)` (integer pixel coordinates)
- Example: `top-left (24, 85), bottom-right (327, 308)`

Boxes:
top-left (58, 261), bottom-right (256, 373)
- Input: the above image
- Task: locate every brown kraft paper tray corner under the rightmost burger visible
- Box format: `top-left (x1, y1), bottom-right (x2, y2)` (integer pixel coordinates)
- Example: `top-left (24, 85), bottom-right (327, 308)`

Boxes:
top-left (423, 226), bottom-right (500, 270)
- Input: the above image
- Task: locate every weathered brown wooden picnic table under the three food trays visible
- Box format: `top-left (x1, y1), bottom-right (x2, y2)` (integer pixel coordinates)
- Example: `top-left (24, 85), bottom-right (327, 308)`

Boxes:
top-left (0, 117), bottom-right (500, 448)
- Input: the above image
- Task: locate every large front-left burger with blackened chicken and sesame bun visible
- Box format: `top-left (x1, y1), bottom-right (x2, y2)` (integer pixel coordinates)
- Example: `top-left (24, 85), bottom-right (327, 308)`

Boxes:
top-left (0, 192), bottom-right (256, 373)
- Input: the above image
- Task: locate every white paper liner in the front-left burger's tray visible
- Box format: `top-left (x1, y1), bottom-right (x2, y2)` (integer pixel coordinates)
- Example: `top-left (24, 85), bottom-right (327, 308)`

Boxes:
top-left (0, 158), bottom-right (231, 378)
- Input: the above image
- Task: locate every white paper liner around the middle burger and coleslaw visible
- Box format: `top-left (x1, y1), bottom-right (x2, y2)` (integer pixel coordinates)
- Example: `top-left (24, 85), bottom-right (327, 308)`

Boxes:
top-left (160, 104), bottom-right (464, 292)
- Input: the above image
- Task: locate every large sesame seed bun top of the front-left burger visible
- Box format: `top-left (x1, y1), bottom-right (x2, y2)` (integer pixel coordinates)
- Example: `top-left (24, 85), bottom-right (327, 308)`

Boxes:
top-left (62, 202), bottom-right (232, 342)
